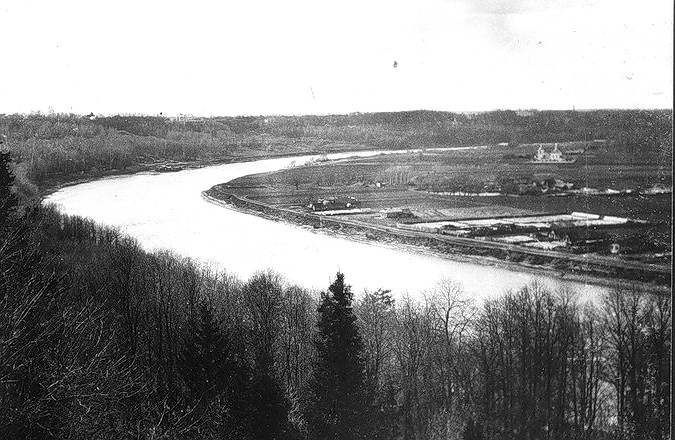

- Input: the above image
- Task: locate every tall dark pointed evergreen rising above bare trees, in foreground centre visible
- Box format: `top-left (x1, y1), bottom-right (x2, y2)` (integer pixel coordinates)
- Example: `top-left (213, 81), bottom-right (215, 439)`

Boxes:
top-left (308, 273), bottom-right (369, 440)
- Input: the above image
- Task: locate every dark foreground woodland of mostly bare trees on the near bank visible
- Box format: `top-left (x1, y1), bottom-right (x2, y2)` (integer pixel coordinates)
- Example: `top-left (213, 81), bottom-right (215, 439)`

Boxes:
top-left (0, 155), bottom-right (671, 440)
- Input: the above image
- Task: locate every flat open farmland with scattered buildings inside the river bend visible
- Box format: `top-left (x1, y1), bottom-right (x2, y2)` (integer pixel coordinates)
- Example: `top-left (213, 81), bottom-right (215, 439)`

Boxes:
top-left (211, 143), bottom-right (672, 280)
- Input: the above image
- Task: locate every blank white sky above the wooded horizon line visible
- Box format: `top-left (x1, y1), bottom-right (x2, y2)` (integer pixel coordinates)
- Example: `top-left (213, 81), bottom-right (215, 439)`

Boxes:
top-left (0, 0), bottom-right (673, 116)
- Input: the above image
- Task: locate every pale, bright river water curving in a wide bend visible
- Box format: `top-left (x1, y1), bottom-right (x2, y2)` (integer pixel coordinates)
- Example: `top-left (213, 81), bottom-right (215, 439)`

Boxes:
top-left (45, 147), bottom-right (605, 298)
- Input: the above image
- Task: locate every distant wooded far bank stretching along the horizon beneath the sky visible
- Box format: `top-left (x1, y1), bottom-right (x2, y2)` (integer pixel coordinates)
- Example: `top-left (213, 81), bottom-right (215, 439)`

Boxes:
top-left (0, 110), bottom-right (672, 184)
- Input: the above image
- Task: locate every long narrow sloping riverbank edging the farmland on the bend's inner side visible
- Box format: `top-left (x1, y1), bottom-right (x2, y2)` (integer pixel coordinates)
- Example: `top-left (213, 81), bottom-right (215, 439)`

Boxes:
top-left (202, 186), bottom-right (670, 294)
